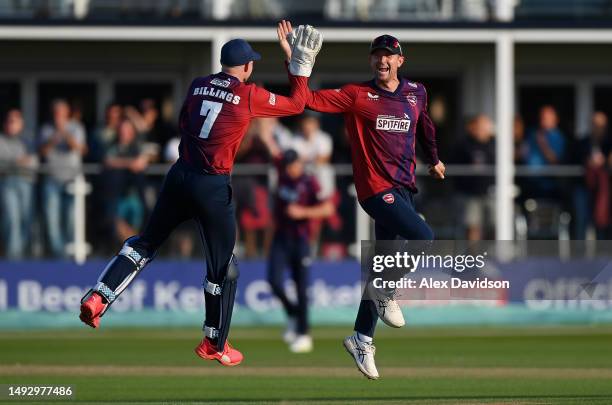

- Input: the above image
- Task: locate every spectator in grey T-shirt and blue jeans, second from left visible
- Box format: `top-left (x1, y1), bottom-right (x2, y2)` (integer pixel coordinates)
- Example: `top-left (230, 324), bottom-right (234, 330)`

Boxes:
top-left (39, 99), bottom-right (87, 257)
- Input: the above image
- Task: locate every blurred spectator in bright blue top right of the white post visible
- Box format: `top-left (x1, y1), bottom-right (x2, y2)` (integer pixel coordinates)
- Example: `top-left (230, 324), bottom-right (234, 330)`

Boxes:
top-left (524, 105), bottom-right (566, 199)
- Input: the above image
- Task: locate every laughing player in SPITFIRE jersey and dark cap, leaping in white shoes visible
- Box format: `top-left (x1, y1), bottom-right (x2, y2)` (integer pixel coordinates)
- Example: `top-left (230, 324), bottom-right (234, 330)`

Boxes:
top-left (280, 24), bottom-right (445, 379)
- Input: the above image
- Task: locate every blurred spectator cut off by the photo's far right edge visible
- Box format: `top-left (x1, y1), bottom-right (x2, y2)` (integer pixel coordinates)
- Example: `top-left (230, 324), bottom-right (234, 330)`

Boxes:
top-left (574, 111), bottom-right (612, 239)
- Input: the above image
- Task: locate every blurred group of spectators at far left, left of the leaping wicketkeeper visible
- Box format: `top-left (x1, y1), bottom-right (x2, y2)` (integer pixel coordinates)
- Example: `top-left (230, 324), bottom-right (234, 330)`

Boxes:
top-left (0, 99), bottom-right (176, 259)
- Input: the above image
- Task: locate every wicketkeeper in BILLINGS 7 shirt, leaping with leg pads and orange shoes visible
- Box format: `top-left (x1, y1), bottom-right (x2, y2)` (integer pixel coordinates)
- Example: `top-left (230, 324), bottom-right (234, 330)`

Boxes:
top-left (80, 26), bottom-right (322, 366)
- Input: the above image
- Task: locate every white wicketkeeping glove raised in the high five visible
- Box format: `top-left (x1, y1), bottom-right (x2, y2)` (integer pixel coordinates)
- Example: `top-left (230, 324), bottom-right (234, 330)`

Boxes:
top-left (287, 25), bottom-right (323, 77)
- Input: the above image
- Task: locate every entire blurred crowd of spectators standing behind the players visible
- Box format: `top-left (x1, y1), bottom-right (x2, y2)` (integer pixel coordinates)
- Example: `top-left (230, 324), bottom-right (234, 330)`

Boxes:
top-left (0, 99), bottom-right (612, 259)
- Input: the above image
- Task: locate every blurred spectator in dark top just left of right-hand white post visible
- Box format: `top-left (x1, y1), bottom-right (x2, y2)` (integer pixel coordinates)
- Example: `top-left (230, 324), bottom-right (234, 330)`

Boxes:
top-left (453, 114), bottom-right (495, 240)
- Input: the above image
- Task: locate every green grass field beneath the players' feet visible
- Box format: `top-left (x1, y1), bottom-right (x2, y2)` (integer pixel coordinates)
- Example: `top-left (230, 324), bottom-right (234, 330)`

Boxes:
top-left (0, 326), bottom-right (612, 404)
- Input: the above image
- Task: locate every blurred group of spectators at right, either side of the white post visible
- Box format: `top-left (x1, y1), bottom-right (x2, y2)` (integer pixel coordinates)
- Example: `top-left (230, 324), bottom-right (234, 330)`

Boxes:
top-left (449, 105), bottom-right (612, 240)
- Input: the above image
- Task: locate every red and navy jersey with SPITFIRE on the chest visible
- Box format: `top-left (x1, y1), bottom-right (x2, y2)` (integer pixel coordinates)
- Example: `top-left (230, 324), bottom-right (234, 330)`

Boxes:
top-left (306, 78), bottom-right (438, 201)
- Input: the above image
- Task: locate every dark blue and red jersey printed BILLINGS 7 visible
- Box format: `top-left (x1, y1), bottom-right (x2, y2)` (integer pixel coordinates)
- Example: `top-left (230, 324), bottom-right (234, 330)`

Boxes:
top-left (179, 66), bottom-right (308, 174)
